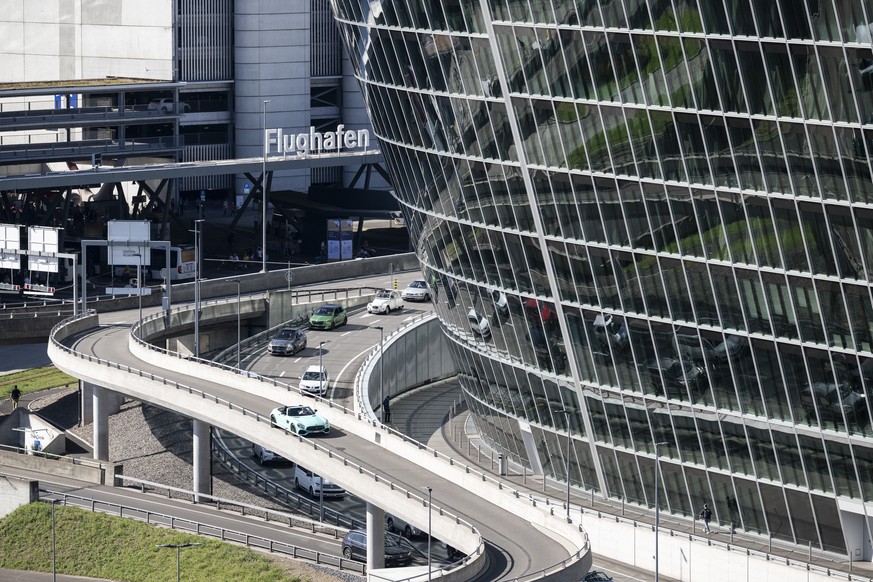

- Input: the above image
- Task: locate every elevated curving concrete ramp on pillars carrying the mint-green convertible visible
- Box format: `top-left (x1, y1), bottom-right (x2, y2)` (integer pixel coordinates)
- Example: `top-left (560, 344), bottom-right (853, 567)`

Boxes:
top-left (49, 298), bottom-right (591, 582)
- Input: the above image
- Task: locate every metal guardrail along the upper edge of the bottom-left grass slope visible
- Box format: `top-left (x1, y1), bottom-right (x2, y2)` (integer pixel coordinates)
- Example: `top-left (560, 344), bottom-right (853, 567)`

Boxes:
top-left (39, 486), bottom-right (366, 575)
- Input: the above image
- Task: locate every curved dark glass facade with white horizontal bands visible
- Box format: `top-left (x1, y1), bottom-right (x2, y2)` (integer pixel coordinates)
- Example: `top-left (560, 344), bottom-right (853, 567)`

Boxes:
top-left (332, 0), bottom-right (873, 559)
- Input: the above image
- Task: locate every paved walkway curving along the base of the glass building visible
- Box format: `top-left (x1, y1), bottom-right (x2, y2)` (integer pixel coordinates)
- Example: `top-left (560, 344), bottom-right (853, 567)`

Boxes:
top-left (391, 380), bottom-right (873, 579)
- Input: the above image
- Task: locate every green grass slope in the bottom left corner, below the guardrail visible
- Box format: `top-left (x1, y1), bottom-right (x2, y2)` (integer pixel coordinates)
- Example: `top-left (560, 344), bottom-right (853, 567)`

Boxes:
top-left (0, 503), bottom-right (307, 582)
